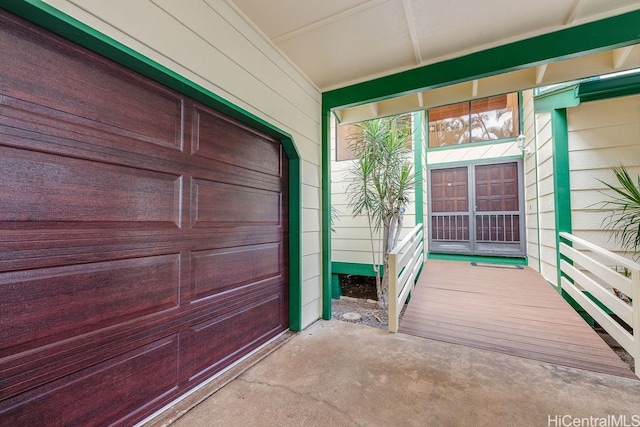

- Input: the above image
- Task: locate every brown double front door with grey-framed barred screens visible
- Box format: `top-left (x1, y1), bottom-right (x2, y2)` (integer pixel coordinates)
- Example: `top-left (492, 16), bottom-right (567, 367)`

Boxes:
top-left (428, 161), bottom-right (525, 256)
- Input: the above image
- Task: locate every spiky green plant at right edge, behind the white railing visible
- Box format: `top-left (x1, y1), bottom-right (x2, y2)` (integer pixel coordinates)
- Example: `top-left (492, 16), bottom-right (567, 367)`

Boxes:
top-left (600, 165), bottom-right (640, 256)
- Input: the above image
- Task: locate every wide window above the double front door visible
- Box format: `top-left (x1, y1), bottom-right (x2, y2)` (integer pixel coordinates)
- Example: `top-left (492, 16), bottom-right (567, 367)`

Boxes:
top-left (428, 93), bottom-right (520, 148)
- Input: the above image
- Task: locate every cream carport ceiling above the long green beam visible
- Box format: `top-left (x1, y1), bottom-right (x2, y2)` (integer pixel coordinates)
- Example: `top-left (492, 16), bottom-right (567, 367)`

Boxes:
top-left (227, 0), bottom-right (640, 91)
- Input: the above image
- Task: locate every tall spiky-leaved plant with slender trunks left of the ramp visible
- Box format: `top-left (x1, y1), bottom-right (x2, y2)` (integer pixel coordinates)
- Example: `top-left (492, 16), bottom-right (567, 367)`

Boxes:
top-left (346, 116), bottom-right (415, 312)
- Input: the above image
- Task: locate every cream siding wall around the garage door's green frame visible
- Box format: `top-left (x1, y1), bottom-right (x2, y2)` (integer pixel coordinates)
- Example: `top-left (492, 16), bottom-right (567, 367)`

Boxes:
top-left (46, 0), bottom-right (322, 327)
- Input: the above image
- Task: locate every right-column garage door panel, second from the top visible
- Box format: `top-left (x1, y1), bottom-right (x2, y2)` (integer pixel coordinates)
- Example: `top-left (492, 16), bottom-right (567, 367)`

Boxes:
top-left (191, 179), bottom-right (282, 227)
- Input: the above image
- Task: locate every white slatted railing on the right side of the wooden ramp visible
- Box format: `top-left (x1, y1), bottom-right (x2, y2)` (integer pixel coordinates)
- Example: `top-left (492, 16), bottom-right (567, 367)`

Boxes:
top-left (560, 233), bottom-right (640, 376)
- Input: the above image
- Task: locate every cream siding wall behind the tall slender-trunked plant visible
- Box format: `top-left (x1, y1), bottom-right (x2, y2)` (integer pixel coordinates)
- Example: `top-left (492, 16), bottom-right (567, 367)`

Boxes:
top-left (330, 115), bottom-right (416, 275)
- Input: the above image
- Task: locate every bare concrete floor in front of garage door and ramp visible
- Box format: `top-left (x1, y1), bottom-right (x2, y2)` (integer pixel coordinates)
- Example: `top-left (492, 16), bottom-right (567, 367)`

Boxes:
top-left (156, 320), bottom-right (640, 427)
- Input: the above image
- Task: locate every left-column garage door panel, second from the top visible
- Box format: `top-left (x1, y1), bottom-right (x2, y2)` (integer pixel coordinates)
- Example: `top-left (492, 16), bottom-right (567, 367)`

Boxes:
top-left (0, 147), bottom-right (182, 226)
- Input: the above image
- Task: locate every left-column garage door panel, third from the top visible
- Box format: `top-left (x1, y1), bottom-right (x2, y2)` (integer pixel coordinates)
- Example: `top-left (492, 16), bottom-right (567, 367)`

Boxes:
top-left (0, 254), bottom-right (180, 356)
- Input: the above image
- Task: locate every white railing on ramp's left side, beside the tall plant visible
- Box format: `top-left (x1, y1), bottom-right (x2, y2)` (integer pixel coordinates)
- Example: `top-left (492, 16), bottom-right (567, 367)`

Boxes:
top-left (385, 224), bottom-right (424, 333)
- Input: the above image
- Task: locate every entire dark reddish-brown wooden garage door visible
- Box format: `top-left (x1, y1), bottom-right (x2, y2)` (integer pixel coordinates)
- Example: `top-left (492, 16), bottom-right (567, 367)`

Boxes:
top-left (0, 12), bottom-right (288, 426)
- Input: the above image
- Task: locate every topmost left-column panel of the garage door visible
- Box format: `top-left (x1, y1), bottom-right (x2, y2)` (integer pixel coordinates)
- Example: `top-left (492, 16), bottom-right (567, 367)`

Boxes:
top-left (0, 15), bottom-right (183, 149)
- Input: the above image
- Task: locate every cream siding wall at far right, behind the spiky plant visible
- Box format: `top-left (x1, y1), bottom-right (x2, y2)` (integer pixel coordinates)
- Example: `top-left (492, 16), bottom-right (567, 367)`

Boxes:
top-left (567, 95), bottom-right (640, 257)
